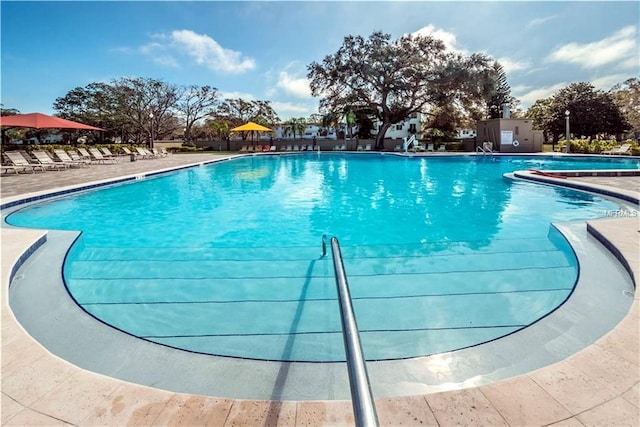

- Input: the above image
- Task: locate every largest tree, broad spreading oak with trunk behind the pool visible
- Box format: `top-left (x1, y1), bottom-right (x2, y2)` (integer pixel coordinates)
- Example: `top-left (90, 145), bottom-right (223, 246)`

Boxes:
top-left (307, 32), bottom-right (494, 148)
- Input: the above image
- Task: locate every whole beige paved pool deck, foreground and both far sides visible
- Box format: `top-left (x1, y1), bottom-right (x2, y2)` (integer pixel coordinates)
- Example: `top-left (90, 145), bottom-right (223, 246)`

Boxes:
top-left (0, 154), bottom-right (640, 426)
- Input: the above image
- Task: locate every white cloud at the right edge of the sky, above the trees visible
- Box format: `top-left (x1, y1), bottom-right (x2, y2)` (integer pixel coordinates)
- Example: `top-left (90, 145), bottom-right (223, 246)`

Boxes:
top-left (546, 25), bottom-right (639, 68)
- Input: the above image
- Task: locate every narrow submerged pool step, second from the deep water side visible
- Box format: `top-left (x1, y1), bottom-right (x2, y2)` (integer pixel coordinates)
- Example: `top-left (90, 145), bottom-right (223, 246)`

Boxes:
top-left (65, 251), bottom-right (570, 280)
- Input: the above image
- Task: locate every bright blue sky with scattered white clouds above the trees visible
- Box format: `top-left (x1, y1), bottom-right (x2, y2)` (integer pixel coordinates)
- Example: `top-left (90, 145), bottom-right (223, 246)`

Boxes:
top-left (0, 0), bottom-right (640, 120)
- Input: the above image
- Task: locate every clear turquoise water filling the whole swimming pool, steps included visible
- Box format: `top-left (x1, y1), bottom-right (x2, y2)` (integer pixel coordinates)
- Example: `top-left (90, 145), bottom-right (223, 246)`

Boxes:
top-left (7, 154), bottom-right (638, 361)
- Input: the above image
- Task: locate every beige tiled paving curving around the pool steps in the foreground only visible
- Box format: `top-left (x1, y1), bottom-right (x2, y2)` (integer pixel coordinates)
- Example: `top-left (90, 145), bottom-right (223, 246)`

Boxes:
top-left (2, 155), bottom-right (639, 425)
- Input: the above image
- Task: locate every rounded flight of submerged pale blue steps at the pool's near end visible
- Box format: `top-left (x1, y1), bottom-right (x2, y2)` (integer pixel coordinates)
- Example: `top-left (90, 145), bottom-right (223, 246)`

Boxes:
top-left (65, 241), bottom-right (577, 362)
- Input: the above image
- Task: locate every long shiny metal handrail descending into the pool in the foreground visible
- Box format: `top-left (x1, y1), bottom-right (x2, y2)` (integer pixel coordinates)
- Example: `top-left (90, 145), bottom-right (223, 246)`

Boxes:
top-left (331, 237), bottom-right (379, 427)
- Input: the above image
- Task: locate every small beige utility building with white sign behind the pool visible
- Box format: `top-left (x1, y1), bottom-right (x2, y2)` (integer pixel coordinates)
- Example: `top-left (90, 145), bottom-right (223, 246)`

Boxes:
top-left (476, 118), bottom-right (543, 153)
